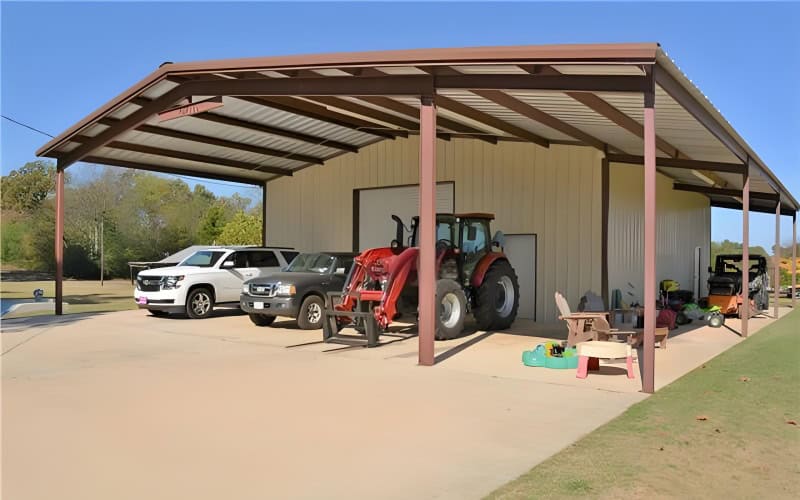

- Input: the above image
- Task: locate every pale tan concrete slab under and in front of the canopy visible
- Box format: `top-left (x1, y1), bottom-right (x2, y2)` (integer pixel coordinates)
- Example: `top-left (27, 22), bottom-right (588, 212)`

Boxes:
top-left (0, 311), bottom-right (788, 499)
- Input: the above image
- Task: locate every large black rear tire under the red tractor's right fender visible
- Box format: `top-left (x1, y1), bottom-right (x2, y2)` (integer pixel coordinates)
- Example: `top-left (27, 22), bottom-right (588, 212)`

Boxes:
top-left (473, 260), bottom-right (519, 330)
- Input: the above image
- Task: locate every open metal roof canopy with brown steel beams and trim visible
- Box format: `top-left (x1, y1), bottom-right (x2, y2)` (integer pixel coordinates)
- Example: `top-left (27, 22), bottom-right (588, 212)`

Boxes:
top-left (37, 43), bottom-right (798, 214)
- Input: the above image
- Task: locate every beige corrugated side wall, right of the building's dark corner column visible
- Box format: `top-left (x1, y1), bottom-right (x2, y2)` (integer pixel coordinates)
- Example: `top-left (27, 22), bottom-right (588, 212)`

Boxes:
top-left (608, 164), bottom-right (711, 302)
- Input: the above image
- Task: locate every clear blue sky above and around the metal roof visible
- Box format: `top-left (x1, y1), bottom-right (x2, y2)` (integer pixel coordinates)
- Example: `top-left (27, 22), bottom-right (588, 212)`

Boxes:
top-left (0, 1), bottom-right (800, 248)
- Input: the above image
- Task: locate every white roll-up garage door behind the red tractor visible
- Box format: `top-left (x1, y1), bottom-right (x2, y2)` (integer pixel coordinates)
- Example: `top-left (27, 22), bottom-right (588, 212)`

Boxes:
top-left (358, 182), bottom-right (455, 250)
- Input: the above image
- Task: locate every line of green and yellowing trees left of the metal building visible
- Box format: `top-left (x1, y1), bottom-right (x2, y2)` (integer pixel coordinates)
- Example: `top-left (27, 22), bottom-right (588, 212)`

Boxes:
top-left (0, 160), bottom-right (262, 279)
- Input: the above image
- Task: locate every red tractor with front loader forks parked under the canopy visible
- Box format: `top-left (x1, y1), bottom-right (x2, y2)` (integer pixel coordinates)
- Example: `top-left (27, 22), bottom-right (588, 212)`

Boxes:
top-left (323, 214), bottom-right (519, 347)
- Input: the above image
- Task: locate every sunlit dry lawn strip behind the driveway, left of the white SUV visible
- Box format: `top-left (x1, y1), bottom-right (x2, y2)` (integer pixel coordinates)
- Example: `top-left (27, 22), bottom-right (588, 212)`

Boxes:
top-left (0, 279), bottom-right (136, 319)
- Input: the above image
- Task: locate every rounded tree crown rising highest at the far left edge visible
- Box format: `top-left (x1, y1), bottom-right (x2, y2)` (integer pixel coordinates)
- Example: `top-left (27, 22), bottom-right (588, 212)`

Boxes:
top-left (2, 160), bottom-right (56, 212)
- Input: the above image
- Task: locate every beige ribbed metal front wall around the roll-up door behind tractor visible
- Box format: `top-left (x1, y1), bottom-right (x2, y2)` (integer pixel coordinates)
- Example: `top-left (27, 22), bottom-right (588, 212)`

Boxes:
top-left (267, 136), bottom-right (602, 321)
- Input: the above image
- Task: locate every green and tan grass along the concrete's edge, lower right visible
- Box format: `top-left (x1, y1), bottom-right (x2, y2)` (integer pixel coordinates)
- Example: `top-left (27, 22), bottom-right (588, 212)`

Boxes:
top-left (489, 311), bottom-right (800, 499)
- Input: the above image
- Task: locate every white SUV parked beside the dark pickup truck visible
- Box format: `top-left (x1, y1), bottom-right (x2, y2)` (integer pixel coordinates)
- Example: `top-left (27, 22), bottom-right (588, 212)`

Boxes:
top-left (133, 247), bottom-right (298, 319)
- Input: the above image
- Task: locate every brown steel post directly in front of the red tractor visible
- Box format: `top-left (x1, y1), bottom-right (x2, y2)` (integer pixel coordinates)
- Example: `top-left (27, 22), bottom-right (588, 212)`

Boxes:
top-left (418, 96), bottom-right (436, 366)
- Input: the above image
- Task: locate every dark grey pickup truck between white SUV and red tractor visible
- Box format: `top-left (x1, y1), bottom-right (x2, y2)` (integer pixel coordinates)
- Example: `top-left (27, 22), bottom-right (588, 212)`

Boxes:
top-left (239, 252), bottom-right (355, 330)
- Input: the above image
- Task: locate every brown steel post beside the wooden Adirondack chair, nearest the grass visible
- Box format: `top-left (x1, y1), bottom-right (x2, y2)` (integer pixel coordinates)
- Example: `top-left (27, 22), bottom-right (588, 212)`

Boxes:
top-left (642, 82), bottom-right (656, 394)
